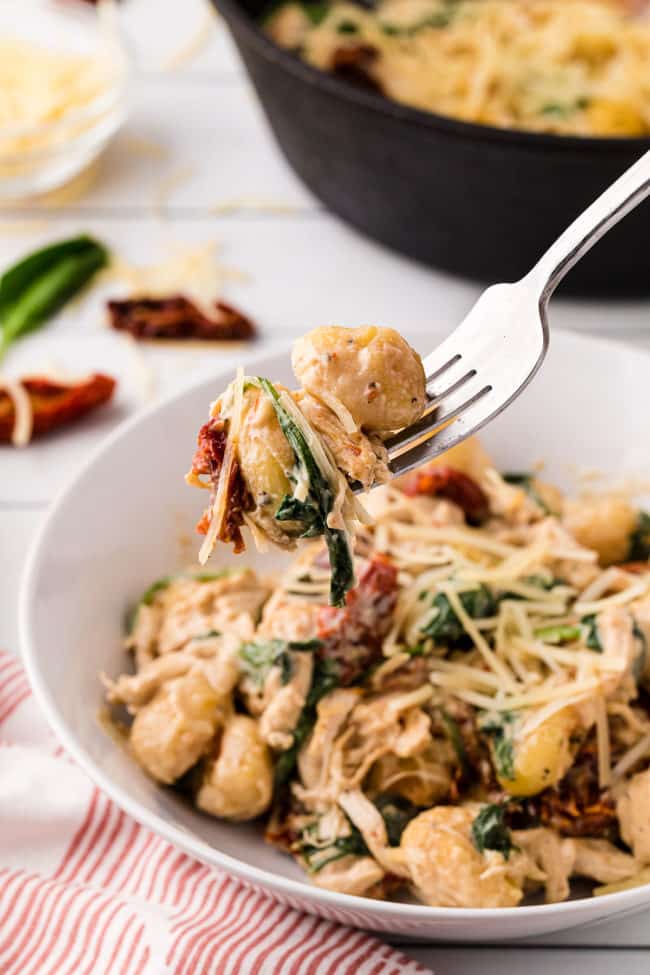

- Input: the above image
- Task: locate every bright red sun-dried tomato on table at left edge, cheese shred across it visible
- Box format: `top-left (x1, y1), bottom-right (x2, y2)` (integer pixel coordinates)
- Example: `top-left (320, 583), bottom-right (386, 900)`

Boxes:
top-left (0, 373), bottom-right (116, 443)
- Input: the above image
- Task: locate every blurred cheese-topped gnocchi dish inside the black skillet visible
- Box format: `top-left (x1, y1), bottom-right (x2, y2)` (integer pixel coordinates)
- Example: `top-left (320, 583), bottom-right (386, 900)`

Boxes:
top-left (264, 0), bottom-right (650, 136)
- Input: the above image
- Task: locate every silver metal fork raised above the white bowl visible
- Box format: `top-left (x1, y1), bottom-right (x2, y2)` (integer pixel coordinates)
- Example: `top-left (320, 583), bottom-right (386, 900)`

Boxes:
top-left (386, 152), bottom-right (650, 476)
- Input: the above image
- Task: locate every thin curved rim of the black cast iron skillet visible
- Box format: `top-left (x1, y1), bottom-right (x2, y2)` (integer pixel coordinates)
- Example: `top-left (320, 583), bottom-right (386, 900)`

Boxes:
top-left (210, 0), bottom-right (650, 155)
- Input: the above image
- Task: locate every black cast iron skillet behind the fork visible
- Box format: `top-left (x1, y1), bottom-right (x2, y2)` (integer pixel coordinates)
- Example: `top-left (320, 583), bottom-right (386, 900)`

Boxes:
top-left (214, 0), bottom-right (650, 296)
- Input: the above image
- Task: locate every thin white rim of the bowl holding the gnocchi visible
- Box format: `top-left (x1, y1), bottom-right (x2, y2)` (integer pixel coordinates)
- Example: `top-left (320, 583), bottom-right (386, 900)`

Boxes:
top-left (18, 329), bottom-right (650, 924)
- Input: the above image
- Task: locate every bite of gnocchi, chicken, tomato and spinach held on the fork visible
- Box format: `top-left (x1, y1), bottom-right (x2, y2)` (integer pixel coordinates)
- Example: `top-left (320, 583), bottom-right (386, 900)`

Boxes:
top-left (187, 326), bottom-right (425, 605)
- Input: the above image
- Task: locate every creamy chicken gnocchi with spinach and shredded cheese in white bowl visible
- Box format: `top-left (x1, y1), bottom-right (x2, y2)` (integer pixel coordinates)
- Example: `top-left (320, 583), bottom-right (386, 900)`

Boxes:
top-left (106, 434), bottom-right (650, 907)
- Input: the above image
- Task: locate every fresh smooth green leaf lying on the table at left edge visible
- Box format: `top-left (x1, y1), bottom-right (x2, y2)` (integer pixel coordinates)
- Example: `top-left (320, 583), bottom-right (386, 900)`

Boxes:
top-left (0, 237), bottom-right (108, 358)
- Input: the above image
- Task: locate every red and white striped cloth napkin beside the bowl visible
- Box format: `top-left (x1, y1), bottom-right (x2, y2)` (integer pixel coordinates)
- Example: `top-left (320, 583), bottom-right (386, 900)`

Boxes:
top-left (0, 653), bottom-right (427, 975)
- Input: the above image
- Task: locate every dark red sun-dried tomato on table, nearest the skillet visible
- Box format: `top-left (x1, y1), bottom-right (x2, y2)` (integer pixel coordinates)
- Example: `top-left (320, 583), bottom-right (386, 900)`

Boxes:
top-left (107, 295), bottom-right (255, 341)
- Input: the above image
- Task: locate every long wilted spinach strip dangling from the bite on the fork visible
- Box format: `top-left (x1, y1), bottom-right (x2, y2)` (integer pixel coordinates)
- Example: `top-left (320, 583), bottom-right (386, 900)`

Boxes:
top-left (258, 377), bottom-right (354, 606)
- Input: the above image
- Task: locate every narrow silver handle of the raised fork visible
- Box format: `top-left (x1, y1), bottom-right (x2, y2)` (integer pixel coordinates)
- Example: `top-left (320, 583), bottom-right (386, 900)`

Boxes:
top-left (524, 151), bottom-right (650, 304)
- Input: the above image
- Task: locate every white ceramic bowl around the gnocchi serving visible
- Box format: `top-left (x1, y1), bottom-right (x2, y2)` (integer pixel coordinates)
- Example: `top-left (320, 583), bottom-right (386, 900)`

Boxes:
top-left (20, 333), bottom-right (650, 941)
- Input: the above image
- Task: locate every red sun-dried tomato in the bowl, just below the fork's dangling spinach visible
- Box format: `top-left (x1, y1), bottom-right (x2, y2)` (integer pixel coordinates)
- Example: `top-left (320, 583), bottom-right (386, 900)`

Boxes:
top-left (317, 555), bottom-right (398, 685)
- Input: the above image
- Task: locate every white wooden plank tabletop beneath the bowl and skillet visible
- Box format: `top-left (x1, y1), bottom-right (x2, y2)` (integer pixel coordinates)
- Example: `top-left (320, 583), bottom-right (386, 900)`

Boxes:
top-left (0, 0), bottom-right (650, 975)
